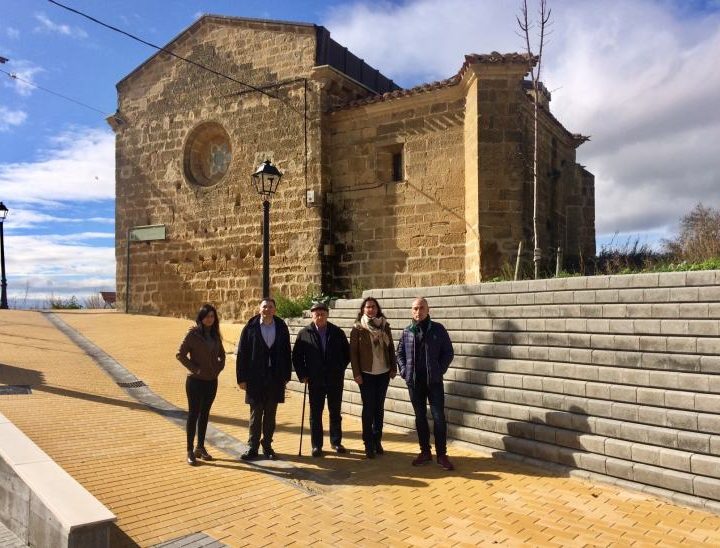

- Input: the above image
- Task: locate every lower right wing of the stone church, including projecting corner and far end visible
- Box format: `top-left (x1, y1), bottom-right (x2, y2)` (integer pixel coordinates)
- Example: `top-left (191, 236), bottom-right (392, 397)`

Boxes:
top-left (330, 62), bottom-right (595, 290)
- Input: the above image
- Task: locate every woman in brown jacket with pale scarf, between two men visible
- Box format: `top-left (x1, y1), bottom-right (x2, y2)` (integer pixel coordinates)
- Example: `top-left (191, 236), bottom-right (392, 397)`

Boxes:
top-left (350, 297), bottom-right (397, 459)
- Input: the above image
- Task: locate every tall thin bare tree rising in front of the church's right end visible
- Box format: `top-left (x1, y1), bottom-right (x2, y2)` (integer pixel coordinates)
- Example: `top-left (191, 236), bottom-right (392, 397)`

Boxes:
top-left (517, 0), bottom-right (552, 279)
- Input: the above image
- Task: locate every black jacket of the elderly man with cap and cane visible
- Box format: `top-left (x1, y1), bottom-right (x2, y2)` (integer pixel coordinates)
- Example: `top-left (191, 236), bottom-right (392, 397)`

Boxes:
top-left (293, 322), bottom-right (350, 384)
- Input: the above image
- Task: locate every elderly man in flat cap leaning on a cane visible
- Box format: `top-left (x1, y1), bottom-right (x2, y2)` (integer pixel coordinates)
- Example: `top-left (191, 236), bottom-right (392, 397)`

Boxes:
top-left (292, 303), bottom-right (350, 457)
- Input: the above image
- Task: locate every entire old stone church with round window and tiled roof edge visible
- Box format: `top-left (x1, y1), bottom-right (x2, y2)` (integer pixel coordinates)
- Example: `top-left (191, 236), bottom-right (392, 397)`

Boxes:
top-left (108, 15), bottom-right (595, 319)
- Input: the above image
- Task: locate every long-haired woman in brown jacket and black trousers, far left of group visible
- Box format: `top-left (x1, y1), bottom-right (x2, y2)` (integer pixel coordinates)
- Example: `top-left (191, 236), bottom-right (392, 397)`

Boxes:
top-left (176, 304), bottom-right (225, 466)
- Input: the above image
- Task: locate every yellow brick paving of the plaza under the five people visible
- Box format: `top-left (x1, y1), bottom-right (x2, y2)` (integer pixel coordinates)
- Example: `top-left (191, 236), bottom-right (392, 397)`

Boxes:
top-left (0, 310), bottom-right (720, 546)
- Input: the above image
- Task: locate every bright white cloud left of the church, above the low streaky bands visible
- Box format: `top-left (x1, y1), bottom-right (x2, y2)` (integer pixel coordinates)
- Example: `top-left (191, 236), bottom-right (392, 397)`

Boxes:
top-left (0, 128), bottom-right (115, 204)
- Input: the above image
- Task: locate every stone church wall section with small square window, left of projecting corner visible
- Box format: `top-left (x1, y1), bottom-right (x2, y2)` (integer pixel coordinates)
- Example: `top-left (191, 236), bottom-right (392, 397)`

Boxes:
top-left (326, 87), bottom-right (465, 290)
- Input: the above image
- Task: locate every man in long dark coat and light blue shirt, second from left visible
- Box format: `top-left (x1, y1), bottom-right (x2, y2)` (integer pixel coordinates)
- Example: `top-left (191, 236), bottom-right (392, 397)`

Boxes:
top-left (236, 299), bottom-right (292, 460)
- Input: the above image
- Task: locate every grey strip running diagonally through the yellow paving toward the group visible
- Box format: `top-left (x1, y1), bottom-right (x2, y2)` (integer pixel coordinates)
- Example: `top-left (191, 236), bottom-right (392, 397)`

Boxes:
top-left (43, 312), bottom-right (336, 496)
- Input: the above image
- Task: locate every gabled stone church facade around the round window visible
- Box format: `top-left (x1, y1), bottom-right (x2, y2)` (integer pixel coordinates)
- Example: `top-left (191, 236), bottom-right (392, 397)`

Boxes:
top-left (116, 18), bottom-right (330, 317)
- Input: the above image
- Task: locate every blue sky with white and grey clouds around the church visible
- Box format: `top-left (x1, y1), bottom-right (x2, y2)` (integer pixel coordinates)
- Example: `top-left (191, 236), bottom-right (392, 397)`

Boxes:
top-left (0, 0), bottom-right (720, 303)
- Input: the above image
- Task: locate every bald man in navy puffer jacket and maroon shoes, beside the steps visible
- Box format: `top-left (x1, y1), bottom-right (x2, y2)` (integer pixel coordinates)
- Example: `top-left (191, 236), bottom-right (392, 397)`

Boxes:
top-left (397, 298), bottom-right (454, 470)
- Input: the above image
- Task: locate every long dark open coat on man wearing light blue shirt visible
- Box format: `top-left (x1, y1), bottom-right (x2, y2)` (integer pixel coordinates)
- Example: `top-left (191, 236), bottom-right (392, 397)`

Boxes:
top-left (236, 314), bottom-right (292, 405)
